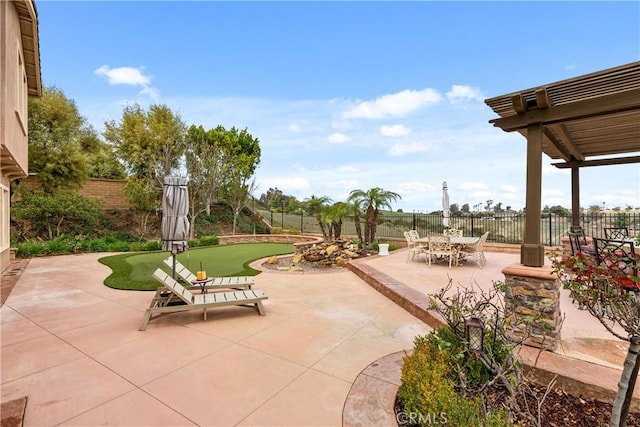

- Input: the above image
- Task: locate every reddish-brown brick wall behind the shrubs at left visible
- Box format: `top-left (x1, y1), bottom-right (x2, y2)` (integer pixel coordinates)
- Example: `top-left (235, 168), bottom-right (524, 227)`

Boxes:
top-left (13, 176), bottom-right (132, 209)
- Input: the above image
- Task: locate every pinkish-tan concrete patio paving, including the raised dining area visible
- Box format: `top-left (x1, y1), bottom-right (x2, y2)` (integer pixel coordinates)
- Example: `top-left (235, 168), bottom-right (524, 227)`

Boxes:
top-left (0, 250), bottom-right (637, 426)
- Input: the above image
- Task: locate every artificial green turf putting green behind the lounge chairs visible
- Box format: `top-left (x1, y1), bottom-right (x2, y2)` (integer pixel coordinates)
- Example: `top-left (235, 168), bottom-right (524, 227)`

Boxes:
top-left (100, 243), bottom-right (293, 291)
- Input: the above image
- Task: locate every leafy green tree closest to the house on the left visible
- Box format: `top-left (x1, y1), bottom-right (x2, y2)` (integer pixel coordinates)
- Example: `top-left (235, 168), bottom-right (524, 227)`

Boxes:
top-left (29, 87), bottom-right (90, 194)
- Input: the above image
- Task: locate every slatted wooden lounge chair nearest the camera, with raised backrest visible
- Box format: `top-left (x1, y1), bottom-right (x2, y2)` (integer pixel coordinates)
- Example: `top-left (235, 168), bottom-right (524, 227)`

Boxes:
top-left (139, 268), bottom-right (267, 331)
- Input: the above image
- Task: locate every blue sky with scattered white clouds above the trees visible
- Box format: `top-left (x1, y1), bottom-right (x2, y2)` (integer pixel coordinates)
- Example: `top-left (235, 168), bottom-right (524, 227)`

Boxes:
top-left (36, 0), bottom-right (640, 211)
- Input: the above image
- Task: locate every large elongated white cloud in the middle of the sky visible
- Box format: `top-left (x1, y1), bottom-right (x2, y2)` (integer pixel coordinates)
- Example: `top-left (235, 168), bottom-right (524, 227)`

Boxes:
top-left (342, 88), bottom-right (441, 119)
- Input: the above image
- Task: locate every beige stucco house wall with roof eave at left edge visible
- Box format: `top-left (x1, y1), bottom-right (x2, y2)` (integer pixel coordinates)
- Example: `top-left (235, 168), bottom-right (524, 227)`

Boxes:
top-left (0, 0), bottom-right (42, 271)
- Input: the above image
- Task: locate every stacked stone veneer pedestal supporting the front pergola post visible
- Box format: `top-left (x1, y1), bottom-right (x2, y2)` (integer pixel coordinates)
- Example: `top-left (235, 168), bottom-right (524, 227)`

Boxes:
top-left (502, 264), bottom-right (562, 351)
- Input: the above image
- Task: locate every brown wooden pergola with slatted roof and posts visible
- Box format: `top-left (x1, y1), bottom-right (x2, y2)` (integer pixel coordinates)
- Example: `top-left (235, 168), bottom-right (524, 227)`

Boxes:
top-left (485, 61), bottom-right (640, 267)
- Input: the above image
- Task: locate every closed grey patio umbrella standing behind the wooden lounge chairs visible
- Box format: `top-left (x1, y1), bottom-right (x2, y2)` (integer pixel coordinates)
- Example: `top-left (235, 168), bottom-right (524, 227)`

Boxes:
top-left (161, 176), bottom-right (189, 278)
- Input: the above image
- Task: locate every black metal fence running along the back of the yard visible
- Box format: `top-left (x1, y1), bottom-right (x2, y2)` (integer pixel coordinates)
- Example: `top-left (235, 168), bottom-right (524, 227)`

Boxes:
top-left (258, 211), bottom-right (640, 246)
